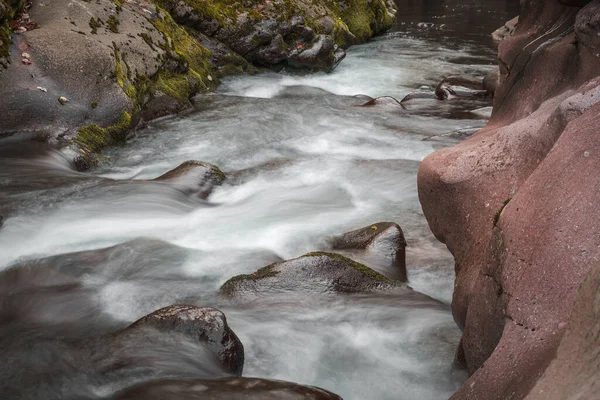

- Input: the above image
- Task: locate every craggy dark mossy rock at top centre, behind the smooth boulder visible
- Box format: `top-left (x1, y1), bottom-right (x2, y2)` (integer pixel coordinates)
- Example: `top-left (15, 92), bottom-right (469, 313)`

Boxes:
top-left (155, 0), bottom-right (396, 71)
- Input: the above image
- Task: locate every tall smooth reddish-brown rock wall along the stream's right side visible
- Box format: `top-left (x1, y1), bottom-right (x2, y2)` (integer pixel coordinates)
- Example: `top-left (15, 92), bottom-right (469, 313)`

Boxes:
top-left (418, 0), bottom-right (600, 399)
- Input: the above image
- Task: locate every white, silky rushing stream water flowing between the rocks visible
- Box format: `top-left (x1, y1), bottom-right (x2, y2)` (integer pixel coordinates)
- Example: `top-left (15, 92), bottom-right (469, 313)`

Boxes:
top-left (0, 1), bottom-right (518, 400)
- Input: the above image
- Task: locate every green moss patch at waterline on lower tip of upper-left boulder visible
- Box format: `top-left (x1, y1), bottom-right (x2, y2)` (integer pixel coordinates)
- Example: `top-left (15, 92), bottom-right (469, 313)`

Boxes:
top-left (73, 111), bottom-right (131, 153)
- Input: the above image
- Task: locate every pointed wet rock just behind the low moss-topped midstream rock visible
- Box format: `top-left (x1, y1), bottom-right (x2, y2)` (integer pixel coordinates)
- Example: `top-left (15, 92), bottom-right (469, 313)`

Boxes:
top-left (330, 222), bottom-right (407, 282)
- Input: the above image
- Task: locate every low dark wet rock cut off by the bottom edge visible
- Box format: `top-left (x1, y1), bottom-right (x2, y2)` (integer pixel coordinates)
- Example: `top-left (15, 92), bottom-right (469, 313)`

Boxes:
top-left (114, 378), bottom-right (341, 400)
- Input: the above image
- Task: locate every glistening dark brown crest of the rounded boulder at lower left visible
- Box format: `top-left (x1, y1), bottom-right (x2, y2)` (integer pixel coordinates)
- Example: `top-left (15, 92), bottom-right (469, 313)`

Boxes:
top-left (125, 305), bottom-right (244, 376)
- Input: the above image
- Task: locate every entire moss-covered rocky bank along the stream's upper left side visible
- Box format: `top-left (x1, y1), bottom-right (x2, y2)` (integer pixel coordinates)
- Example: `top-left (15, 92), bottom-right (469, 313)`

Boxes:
top-left (0, 0), bottom-right (395, 162)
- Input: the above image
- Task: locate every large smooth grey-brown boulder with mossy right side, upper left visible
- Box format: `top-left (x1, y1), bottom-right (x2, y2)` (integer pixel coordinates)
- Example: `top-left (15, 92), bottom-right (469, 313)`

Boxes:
top-left (0, 0), bottom-right (218, 162)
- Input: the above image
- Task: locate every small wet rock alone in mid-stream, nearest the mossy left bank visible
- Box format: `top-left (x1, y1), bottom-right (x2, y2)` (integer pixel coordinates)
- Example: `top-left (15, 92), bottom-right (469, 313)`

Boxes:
top-left (154, 161), bottom-right (226, 199)
